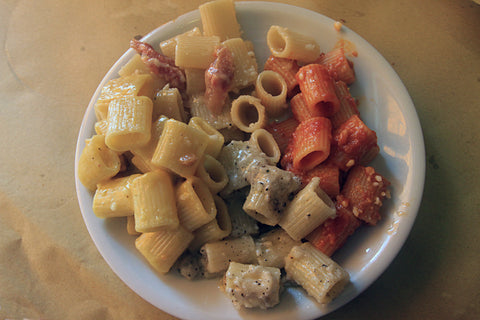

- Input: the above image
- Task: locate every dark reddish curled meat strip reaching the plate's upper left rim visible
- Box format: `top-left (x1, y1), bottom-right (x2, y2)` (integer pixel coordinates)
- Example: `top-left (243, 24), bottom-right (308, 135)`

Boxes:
top-left (130, 39), bottom-right (186, 90)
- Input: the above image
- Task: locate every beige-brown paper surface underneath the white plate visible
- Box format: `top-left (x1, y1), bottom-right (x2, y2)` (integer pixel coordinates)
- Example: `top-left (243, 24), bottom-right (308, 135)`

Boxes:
top-left (0, 0), bottom-right (480, 319)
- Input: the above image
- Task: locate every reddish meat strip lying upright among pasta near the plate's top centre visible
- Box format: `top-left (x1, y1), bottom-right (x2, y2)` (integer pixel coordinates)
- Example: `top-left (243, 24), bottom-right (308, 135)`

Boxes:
top-left (205, 46), bottom-right (235, 115)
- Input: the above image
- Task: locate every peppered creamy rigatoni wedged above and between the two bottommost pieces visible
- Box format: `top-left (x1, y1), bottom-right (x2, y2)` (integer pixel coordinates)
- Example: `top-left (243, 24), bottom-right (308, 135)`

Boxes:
top-left (255, 228), bottom-right (302, 268)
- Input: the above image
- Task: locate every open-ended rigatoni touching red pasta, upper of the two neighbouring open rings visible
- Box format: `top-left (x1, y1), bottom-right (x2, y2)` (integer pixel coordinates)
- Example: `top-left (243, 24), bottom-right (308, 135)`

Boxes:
top-left (255, 70), bottom-right (288, 117)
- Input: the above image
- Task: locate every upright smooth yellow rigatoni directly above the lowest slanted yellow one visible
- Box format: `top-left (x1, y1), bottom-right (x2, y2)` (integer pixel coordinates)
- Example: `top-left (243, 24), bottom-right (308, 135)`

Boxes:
top-left (131, 170), bottom-right (179, 232)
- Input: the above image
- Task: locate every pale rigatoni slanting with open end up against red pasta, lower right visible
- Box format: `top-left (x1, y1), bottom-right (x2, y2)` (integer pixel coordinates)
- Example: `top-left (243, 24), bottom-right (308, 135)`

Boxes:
top-left (279, 177), bottom-right (336, 240)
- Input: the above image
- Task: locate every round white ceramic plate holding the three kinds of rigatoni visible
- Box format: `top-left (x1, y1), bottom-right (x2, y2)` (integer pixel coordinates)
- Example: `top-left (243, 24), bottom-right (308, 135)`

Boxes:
top-left (75, 2), bottom-right (425, 320)
